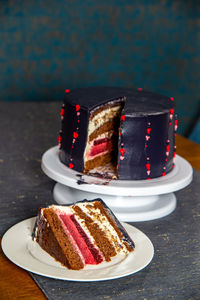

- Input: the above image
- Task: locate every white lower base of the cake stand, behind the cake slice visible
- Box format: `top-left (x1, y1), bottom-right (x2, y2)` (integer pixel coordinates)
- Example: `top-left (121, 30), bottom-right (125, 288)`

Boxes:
top-left (53, 183), bottom-right (176, 222)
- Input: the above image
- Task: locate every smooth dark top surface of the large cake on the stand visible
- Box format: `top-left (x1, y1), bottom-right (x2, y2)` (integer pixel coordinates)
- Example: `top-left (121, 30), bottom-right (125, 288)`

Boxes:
top-left (65, 87), bottom-right (174, 116)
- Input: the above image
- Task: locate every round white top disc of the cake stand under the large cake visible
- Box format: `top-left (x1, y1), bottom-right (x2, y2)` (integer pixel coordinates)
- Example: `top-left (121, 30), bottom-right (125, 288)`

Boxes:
top-left (41, 146), bottom-right (193, 196)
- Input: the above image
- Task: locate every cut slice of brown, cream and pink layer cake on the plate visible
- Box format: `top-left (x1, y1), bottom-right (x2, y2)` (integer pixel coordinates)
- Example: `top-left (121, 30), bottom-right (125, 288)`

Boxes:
top-left (33, 199), bottom-right (135, 270)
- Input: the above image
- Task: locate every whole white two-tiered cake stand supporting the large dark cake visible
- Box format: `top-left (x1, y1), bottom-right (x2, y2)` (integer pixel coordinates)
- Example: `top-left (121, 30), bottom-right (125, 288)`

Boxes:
top-left (41, 146), bottom-right (193, 222)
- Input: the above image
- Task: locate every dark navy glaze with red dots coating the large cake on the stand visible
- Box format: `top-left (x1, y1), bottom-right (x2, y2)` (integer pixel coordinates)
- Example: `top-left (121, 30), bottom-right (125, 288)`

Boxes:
top-left (60, 87), bottom-right (175, 180)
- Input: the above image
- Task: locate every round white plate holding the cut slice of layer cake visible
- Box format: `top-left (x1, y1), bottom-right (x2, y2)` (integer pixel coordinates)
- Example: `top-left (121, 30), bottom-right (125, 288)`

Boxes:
top-left (2, 217), bottom-right (154, 281)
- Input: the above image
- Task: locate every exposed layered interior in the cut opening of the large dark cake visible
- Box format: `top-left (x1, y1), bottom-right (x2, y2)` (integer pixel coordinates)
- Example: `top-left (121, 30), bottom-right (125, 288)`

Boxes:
top-left (84, 98), bottom-right (125, 178)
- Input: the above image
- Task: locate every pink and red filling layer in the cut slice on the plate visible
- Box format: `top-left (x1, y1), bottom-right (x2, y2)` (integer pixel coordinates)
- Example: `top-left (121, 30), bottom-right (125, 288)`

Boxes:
top-left (59, 214), bottom-right (103, 265)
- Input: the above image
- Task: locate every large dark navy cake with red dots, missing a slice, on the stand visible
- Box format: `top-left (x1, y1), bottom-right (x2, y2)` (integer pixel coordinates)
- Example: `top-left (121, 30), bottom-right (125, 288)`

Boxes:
top-left (58, 87), bottom-right (177, 180)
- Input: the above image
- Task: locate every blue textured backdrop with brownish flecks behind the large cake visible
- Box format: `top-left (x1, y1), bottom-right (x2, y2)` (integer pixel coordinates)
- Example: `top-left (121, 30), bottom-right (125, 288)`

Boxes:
top-left (0, 0), bottom-right (200, 135)
